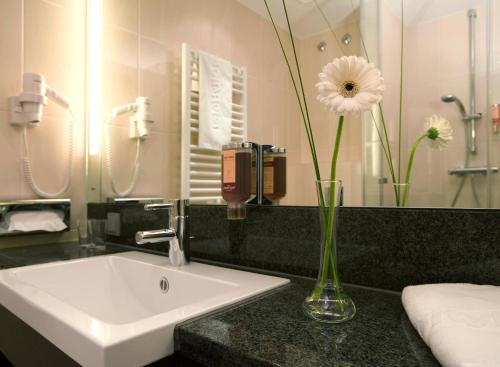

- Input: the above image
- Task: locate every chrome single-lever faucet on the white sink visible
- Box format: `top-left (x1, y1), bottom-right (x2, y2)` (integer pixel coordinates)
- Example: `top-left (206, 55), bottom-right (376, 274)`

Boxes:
top-left (135, 199), bottom-right (190, 265)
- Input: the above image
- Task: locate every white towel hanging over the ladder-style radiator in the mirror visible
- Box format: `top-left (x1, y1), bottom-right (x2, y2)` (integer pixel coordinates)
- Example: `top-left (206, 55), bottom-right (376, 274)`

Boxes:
top-left (198, 52), bottom-right (233, 150)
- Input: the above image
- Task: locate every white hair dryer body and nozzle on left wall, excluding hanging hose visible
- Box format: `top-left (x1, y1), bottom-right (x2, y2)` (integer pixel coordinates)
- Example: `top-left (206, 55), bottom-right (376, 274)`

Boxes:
top-left (9, 73), bottom-right (69, 126)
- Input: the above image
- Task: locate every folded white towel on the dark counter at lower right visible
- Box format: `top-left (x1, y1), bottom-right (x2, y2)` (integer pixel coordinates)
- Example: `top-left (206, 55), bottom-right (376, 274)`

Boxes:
top-left (402, 283), bottom-right (500, 367)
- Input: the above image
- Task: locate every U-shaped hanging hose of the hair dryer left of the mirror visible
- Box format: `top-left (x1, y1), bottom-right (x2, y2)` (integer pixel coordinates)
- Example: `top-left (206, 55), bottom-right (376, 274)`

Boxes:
top-left (22, 109), bottom-right (75, 199)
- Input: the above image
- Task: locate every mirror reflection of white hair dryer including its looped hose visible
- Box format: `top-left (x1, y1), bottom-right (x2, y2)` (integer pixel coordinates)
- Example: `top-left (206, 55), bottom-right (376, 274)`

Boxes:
top-left (104, 97), bottom-right (154, 197)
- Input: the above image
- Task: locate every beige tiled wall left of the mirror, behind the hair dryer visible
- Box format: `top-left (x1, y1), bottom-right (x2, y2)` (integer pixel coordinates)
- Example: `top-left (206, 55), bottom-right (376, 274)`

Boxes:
top-left (0, 0), bottom-right (86, 246)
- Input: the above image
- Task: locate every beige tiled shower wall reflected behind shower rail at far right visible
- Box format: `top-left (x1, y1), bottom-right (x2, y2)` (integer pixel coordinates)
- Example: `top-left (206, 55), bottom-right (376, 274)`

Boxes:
top-left (405, 2), bottom-right (491, 208)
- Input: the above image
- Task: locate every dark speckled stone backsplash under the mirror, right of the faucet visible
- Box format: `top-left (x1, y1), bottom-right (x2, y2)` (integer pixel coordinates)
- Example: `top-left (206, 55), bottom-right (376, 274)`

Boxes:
top-left (191, 205), bottom-right (500, 291)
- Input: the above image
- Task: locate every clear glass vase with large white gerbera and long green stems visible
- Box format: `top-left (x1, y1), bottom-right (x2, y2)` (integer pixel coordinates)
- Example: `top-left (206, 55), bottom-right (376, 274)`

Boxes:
top-left (263, 0), bottom-right (384, 322)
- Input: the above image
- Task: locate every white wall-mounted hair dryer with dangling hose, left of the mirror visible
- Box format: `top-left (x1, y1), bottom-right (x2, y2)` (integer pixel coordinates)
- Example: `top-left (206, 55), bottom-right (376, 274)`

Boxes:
top-left (9, 73), bottom-right (74, 198)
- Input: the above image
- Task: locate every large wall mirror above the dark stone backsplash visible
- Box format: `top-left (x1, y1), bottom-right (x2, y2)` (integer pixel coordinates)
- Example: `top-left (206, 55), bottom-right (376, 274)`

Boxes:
top-left (88, 0), bottom-right (500, 208)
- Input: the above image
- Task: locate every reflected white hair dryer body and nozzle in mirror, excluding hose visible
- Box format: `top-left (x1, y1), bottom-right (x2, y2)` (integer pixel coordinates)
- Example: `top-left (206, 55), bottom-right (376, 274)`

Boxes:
top-left (110, 97), bottom-right (153, 139)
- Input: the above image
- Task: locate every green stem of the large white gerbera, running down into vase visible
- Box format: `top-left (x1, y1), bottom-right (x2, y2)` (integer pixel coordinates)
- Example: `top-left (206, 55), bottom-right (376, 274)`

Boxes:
top-left (320, 116), bottom-right (344, 297)
